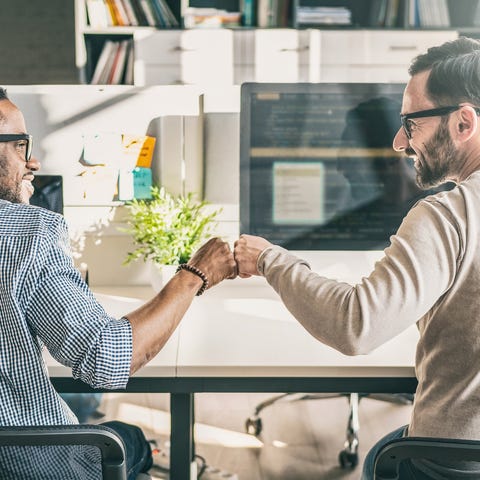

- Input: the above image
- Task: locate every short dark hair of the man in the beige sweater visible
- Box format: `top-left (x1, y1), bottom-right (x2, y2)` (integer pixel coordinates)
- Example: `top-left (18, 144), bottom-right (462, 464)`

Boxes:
top-left (408, 37), bottom-right (480, 106)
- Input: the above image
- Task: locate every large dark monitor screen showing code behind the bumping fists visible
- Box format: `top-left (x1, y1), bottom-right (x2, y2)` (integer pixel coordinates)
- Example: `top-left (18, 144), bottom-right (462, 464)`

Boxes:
top-left (240, 83), bottom-right (452, 250)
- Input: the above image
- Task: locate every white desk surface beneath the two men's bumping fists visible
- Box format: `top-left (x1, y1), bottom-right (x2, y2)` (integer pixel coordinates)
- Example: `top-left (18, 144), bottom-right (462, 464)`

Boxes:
top-left (46, 279), bottom-right (418, 379)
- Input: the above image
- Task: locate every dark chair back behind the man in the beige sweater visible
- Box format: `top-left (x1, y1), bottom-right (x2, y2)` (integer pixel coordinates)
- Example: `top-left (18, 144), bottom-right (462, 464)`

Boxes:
top-left (374, 437), bottom-right (480, 480)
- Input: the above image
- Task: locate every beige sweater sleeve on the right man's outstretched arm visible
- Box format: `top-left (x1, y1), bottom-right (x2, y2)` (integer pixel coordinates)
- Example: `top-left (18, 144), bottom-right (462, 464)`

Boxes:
top-left (259, 200), bottom-right (461, 355)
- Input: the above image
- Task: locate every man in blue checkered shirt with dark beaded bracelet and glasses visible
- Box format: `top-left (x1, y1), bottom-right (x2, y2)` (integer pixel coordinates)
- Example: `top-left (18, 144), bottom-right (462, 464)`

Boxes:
top-left (0, 88), bottom-right (236, 479)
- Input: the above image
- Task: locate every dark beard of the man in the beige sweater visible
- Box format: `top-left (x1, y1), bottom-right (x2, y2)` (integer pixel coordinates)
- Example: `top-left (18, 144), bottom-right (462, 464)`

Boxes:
top-left (415, 119), bottom-right (459, 190)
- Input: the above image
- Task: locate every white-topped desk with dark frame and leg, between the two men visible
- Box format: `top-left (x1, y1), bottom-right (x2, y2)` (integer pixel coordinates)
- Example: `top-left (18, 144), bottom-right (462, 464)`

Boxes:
top-left (47, 279), bottom-right (418, 480)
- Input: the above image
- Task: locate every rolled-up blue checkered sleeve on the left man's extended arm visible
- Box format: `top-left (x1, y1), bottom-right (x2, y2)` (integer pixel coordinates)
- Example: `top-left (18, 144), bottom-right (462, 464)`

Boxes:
top-left (26, 220), bottom-right (132, 389)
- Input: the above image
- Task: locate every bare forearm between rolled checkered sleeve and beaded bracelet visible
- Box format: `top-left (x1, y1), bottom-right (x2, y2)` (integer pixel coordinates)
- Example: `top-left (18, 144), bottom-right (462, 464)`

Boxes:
top-left (126, 270), bottom-right (202, 374)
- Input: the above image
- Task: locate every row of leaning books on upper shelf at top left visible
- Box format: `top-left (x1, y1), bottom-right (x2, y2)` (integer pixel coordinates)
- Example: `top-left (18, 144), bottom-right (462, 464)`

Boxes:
top-left (86, 0), bottom-right (179, 28)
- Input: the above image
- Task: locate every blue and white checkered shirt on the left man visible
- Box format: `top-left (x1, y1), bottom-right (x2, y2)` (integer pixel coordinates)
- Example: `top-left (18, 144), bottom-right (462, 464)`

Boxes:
top-left (0, 200), bottom-right (132, 425)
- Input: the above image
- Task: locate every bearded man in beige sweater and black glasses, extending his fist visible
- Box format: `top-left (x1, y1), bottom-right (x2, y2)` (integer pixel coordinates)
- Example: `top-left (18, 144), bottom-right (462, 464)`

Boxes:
top-left (234, 38), bottom-right (480, 480)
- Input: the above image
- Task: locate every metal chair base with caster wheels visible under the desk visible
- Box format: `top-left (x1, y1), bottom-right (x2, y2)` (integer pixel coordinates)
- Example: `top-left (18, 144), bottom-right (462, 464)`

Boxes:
top-left (245, 393), bottom-right (414, 469)
